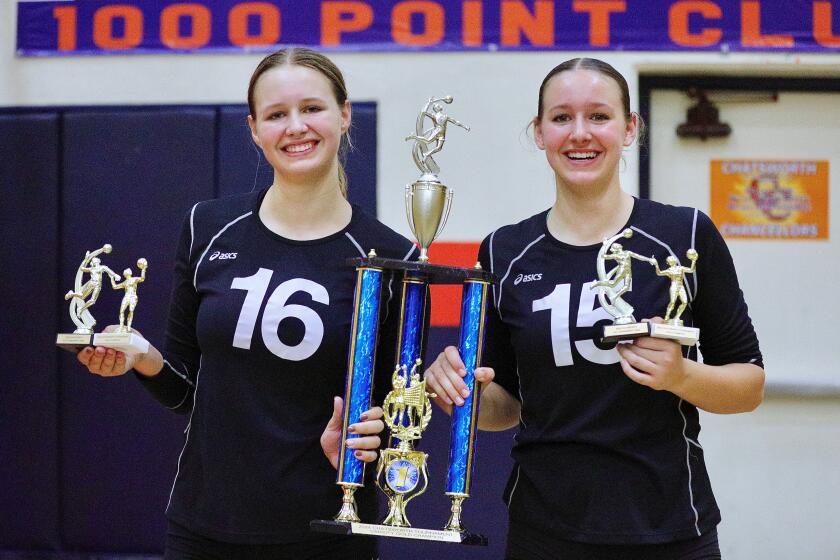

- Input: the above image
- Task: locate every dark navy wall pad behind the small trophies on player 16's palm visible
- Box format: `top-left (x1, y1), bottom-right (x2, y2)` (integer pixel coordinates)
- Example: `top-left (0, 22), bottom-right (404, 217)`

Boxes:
top-left (59, 109), bottom-right (216, 551)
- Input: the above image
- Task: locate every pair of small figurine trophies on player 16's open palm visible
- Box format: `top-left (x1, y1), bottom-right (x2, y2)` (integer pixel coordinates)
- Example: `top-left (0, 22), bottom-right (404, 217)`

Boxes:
top-left (55, 243), bottom-right (149, 354)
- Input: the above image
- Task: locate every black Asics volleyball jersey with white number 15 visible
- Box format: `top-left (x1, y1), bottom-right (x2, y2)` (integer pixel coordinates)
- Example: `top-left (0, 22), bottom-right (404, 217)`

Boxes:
top-left (479, 199), bottom-right (762, 544)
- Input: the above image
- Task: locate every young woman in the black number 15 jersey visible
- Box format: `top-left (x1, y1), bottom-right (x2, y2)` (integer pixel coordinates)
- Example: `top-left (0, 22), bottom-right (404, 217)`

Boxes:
top-left (427, 59), bottom-right (764, 560)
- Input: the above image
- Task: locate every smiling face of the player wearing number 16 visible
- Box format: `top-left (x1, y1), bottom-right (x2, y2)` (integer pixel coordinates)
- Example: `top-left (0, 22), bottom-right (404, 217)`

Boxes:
top-left (248, 64), bottom-right (350, 189)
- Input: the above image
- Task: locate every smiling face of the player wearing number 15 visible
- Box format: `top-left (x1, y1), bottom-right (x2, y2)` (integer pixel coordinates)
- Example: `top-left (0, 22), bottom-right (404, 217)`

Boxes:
top-left (534, 68), bottom-right (636, 197)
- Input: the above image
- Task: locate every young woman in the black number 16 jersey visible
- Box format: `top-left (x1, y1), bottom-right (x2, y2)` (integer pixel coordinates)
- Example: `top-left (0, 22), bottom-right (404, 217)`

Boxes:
top-left (79, 49), bottom-right (415, 560)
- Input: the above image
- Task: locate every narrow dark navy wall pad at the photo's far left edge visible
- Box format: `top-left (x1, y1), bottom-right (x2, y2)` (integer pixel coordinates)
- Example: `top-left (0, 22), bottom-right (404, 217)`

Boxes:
top-left (0, 113), bottom-right (60, 548)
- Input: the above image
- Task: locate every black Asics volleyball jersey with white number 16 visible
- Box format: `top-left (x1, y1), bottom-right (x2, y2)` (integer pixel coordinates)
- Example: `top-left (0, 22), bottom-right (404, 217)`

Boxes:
top-left (138, 191), bottom-right (414, 543)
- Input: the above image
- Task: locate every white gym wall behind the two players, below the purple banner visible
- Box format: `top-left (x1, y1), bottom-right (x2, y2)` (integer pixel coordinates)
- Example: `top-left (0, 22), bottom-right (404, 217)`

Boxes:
top-left (6, 2), bottom-right (840, 560)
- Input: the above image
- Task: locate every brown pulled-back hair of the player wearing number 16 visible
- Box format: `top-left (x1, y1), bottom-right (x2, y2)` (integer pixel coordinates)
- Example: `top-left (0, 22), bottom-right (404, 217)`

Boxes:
top-left (248, 47), bottom-right (351, 198)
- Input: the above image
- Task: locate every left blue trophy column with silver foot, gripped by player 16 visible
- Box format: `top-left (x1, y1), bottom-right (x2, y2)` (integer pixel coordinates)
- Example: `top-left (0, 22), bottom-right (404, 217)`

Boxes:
top-left (335, 266), bottom-right (382, 522)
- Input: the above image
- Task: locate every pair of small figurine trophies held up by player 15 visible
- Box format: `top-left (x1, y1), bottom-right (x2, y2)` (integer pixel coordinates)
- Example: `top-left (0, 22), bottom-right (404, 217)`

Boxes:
top-left (592, 228), bottom-right (700, 346)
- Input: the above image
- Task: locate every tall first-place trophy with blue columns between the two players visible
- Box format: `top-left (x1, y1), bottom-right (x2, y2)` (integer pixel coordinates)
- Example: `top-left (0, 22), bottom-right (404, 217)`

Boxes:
top-left (311, 96), bottom-right (491, 545)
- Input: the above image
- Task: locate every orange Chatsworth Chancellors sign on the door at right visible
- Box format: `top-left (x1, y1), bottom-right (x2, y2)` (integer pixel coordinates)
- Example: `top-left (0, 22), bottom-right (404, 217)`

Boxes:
top-left (710, 160), bottom-right (828, 239)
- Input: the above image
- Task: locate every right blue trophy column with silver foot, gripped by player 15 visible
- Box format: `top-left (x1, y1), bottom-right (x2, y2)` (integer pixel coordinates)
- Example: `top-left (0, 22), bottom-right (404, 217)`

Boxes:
top-left (446, 280), bottom-right (490, 531)
